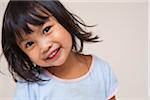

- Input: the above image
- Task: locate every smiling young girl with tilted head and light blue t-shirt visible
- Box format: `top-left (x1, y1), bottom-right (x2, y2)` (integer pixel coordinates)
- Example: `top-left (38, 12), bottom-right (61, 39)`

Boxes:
top-left (2, 0), bottom-right (118, 100)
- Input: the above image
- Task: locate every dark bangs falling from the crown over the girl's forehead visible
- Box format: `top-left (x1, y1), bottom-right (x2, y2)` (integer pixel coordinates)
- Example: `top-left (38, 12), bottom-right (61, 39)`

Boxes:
top-left (7, 1), bottom-right (51, 40)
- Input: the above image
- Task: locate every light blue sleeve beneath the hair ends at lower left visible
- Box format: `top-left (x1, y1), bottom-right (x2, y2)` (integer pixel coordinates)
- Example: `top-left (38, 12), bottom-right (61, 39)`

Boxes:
top-left (13, 82), bottom-right (34, 100)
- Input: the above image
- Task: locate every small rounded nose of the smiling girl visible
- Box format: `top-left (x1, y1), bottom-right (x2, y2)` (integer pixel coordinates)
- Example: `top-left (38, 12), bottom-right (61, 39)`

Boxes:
top-left (39, 38), bottom-right (52, 53)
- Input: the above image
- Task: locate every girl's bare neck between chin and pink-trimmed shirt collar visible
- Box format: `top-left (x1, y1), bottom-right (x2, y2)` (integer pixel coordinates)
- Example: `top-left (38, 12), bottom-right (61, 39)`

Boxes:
top-left (45, 52), bottom-right (88, 79)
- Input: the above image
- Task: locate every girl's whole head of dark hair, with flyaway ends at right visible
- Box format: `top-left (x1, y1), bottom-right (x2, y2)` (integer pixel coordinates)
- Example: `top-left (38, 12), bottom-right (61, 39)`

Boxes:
top-left (2, 0), bottom-right (98, 82)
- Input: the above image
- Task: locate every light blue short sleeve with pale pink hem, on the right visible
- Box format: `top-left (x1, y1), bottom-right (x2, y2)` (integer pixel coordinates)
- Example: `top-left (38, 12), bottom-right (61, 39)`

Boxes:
top-left (104, 63), bottom-right (118, 100)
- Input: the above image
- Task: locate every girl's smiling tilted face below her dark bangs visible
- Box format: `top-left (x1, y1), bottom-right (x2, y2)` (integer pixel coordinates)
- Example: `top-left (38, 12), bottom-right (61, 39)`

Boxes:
top-left (17, 17), bottom-right (72, 67)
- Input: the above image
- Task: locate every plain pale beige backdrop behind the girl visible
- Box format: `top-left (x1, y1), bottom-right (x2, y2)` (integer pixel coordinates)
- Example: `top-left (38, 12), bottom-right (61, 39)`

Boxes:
top-left (0, 0), bottom-right (148, 100)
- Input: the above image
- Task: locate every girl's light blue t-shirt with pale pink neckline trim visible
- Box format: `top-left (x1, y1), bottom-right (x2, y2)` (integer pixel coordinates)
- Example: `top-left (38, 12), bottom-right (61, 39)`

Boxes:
top-left (14, 56), bottom-right (118, 100)
